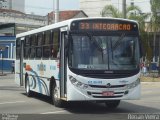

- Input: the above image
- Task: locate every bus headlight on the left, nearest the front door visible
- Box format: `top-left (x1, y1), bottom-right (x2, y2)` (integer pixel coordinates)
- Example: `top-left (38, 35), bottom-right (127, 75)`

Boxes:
top-left (69, 75), bottom-right (88, 89)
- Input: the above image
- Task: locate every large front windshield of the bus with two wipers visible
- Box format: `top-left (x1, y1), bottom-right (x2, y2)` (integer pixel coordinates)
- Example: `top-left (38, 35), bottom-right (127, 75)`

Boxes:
top-left (69, 33), bottom-right (140, 70)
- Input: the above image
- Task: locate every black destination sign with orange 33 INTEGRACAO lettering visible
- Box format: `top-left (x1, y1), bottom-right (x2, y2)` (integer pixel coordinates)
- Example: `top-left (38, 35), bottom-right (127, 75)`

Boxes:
top-left (71, 20), bottom-right (138, 31)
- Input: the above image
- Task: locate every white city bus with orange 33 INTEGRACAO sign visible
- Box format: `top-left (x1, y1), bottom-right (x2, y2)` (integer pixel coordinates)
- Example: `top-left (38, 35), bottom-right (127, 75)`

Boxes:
top-left (15, 18), bottom-right (141, 108)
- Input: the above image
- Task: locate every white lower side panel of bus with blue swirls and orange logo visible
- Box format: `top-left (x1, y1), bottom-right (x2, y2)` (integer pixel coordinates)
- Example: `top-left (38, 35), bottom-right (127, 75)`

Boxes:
top-left (23, 60), bottom-right (59, 96)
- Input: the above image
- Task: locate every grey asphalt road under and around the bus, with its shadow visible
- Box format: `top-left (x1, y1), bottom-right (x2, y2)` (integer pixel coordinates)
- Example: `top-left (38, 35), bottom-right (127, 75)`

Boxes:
top-left (0, 74), bottom-right (160, 120)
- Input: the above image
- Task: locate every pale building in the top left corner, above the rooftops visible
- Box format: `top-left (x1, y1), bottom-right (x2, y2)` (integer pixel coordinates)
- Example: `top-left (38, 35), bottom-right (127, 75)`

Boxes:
top-left (0, 0), bottom-right (25, 12)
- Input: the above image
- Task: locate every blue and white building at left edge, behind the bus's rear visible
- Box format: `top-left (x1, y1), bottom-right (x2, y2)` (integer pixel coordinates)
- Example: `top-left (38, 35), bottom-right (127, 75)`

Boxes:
top-left (0, 23), bottom-right (16, 73)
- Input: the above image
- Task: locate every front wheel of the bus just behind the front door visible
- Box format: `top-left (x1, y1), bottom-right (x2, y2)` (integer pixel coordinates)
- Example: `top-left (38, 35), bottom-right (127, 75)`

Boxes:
top-left (52, 84), bottom-right (64, 107)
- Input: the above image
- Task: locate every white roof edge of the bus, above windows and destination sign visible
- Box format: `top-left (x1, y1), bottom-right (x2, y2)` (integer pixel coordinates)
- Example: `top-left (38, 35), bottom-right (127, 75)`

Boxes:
top-left (16, 17), bottom-right (138, 38)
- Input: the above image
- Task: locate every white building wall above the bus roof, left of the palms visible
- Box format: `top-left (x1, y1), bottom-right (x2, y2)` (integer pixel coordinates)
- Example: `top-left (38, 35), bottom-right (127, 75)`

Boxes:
top-left (80, 0), bottom-right (111, 17)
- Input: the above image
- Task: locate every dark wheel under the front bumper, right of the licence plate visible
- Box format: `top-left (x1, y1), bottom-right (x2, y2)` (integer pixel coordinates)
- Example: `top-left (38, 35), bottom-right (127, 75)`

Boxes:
top-left (105, 100), bottom-right (120, 109)
